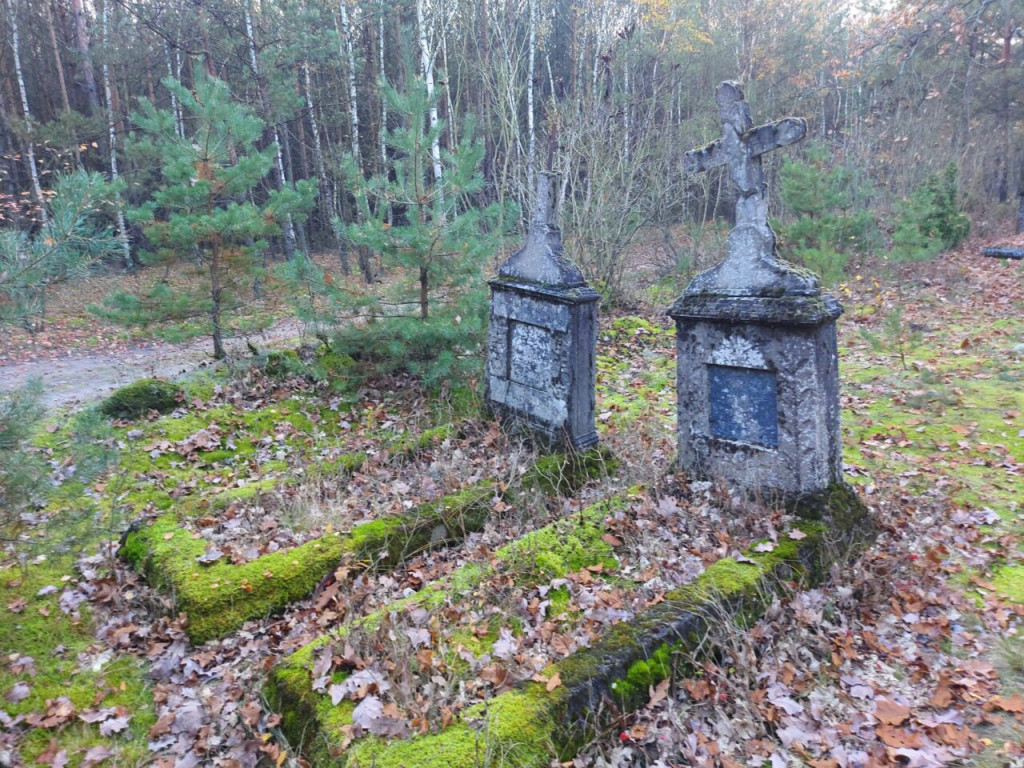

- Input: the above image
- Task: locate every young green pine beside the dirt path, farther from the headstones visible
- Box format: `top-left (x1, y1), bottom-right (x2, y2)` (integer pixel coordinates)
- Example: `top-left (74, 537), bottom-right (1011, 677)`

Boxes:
top-left (96, 68), bottom-right (315, 359)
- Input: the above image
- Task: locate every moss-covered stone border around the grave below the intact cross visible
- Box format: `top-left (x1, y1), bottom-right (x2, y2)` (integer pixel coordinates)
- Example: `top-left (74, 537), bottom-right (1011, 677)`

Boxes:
top-left (266, 484), bottom-right (873, 768)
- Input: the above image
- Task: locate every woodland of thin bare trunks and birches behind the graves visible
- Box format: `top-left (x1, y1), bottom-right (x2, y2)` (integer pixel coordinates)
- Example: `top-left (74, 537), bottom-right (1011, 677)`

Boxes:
top-left (0, 0), bottom-right (1024, 289)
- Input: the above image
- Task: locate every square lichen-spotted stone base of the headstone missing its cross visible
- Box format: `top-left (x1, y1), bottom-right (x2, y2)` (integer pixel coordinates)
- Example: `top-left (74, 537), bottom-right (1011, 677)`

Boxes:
top-left (485, 276), bottom-right (599, 451)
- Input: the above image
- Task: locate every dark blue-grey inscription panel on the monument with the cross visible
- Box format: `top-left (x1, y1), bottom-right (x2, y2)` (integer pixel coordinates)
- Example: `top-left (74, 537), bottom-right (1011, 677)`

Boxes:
top-left (708, 366), bottom-right (778, 447)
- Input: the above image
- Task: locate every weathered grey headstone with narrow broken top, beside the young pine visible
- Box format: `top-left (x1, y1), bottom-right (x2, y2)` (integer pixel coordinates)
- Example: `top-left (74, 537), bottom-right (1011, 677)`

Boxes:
top-left (485, 173), bottom-right (598, 450)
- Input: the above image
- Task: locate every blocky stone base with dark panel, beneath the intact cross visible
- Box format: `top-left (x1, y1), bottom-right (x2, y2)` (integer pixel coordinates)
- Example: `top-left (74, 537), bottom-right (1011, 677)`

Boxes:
top-left (669, 294), bottom-right (842, 502)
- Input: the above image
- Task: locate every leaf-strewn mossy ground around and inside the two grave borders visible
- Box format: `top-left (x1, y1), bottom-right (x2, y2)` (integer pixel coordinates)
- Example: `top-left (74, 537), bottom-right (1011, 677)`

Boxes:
top-left (0, 230), bottom-right (1024, 768)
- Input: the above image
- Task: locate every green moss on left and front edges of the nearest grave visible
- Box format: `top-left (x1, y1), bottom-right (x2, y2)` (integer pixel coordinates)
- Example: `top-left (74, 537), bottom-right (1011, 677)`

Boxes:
top-left (264, 492), bottom-right (632, 767)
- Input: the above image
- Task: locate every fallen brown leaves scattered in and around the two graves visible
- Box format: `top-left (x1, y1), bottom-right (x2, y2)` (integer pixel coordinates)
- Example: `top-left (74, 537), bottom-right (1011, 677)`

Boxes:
top-left (0, 237), bottom-right (1024, 768)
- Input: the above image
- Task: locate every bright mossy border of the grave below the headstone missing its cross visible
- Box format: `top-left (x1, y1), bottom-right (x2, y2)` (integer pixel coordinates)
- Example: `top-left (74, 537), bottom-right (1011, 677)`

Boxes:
top-left (119, 442), bottom-right (614, 644)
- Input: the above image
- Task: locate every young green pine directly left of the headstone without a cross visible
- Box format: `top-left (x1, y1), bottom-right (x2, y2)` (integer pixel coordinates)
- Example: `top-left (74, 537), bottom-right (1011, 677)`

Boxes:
top-left (289, 76), bottom-right (512, 385)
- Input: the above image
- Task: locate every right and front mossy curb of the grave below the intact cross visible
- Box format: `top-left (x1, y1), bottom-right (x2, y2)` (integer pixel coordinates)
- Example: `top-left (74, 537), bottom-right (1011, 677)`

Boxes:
top-left (296, 484), bottom-right (872, 768)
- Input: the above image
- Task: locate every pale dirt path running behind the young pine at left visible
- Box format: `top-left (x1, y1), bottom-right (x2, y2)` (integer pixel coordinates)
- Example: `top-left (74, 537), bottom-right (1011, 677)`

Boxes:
top-left (0, 317), bottom-right (302, 408)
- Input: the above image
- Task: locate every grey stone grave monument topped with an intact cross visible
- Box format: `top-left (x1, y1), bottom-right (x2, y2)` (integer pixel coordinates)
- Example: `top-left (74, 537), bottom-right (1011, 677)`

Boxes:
top-left (669, 82), bottom-right (843, 500)
